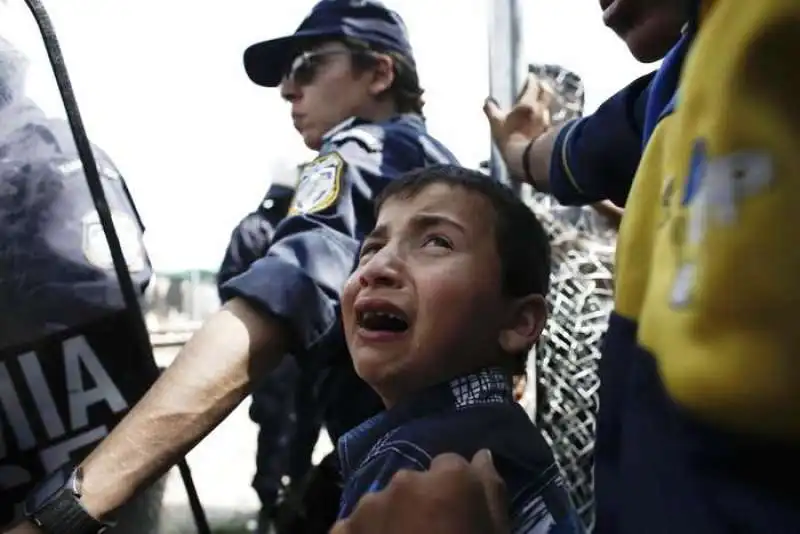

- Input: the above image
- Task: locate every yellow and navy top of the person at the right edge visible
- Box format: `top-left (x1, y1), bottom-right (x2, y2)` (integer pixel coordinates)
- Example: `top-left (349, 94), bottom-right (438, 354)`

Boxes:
top-left (551, 0), bottom-right (800, 534)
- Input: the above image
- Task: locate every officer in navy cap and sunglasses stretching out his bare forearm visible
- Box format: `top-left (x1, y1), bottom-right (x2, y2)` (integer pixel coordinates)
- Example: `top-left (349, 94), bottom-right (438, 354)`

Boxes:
top-left (9, 0), bottom-right (462, 534)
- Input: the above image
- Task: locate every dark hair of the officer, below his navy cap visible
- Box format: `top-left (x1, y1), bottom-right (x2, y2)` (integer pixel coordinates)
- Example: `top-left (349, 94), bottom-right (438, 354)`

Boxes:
top-left (344, 39), bottom-right (425, 116)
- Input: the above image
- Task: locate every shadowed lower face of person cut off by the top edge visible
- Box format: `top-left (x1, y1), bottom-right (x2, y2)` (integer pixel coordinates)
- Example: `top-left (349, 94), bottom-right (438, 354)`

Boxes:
top-left (600, 0), bottom-right (689, 62)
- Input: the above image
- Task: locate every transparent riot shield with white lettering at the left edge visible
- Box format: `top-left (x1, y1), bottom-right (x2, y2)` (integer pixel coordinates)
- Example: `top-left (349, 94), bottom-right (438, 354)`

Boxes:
top-left (0, 0), bottom-right (206, 532)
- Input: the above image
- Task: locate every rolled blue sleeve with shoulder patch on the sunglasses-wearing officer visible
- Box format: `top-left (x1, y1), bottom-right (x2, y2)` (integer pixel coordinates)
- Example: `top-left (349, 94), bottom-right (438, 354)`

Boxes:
top-left (221, 129), bottom-right (410, 351)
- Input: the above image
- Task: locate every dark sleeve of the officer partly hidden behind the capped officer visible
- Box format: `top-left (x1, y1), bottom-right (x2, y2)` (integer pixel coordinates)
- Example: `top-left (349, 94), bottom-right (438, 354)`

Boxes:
top-left (217, 185), bottom-right (294, 294)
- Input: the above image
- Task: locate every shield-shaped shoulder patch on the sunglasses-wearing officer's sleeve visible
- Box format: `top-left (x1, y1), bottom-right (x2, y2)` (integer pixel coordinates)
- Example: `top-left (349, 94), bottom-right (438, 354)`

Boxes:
top-left (289, 153), bottom-right (344, 215)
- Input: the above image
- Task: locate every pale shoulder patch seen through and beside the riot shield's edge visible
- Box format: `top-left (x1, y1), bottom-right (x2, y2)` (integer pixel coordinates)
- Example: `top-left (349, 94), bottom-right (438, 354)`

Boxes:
top-left (81, 211), bottom-right (147, 273)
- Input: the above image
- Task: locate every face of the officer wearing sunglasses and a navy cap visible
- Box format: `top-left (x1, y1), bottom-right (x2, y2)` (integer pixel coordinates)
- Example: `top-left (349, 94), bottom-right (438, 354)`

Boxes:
top-left (281, 42), bottom-right (386, 150)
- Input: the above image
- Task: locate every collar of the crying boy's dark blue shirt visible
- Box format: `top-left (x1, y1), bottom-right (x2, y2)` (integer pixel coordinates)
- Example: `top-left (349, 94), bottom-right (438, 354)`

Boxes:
top-left (337, 367), bottom-right (514, 480)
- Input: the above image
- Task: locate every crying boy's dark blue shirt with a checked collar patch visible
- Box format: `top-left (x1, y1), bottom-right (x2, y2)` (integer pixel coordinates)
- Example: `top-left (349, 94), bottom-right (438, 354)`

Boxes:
top-left (338, 368), bottom-right (583, 534)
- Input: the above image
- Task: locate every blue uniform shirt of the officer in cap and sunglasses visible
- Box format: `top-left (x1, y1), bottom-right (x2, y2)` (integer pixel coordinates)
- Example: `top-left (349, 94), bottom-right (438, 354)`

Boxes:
top-left (220, 114), bottom-right (456, 439)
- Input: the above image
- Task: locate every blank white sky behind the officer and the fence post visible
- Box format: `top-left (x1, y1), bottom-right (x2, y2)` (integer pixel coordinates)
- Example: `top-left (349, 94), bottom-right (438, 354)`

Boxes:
top-left (0, 0), bottom-right (653, 271)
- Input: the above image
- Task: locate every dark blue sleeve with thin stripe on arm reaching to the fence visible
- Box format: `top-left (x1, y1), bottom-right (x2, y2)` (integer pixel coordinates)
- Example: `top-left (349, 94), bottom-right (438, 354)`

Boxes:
top-left (550, 74), bottom-right (653, 206)
